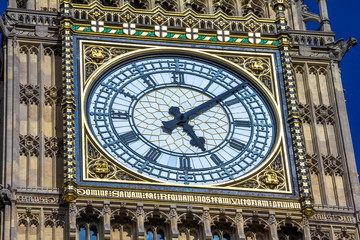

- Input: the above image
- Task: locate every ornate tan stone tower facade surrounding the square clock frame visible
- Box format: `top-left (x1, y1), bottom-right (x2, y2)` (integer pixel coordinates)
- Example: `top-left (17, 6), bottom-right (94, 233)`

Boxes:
top-left (0, 0), bottom-right (360, 240)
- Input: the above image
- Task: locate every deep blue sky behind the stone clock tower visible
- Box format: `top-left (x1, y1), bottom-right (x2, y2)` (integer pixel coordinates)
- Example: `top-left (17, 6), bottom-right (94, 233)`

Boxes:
top-left (0, 0), bottom-right (360, 178)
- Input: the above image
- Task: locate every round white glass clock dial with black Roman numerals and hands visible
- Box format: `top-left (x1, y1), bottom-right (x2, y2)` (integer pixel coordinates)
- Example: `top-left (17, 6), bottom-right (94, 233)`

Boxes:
top-left (86, 56), bottom-right (276, 185)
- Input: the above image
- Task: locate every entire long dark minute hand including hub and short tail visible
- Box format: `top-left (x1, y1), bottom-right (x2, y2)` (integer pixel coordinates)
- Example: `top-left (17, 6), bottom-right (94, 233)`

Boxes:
top-left (162, 83), bottom-right (247, 134)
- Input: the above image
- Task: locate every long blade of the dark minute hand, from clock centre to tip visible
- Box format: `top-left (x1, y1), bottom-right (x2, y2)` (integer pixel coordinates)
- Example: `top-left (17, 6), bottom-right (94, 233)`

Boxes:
top-left (183, 83), bottom-right (247, 121)
